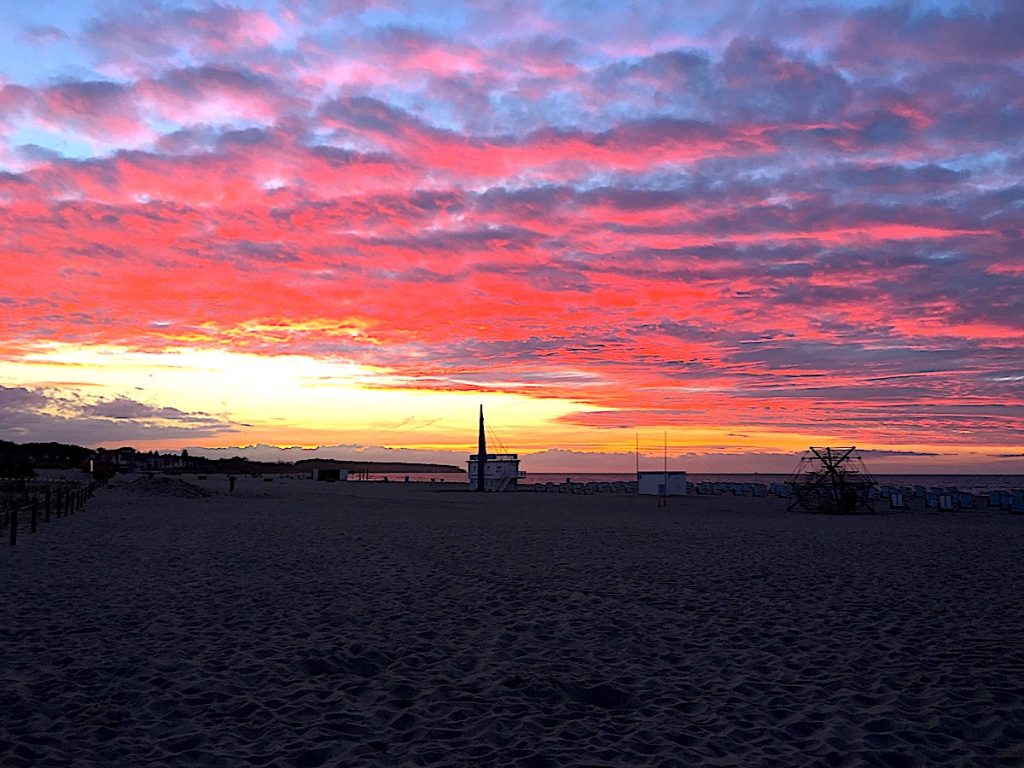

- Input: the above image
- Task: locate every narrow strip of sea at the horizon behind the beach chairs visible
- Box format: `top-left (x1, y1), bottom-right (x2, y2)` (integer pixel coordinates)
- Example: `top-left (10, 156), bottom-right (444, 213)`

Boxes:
top-left (349, 472), bottom-right (1024, 494)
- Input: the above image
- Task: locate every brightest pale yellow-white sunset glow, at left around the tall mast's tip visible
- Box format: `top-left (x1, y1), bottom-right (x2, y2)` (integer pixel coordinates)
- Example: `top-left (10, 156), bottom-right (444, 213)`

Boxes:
top-left (0, 343), bottom-right (588, 451)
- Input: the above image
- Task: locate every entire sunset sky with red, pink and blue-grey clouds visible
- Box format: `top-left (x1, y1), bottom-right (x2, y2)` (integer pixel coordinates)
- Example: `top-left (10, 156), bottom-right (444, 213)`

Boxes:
top-left (0, 0), bottom-right (1024, 473)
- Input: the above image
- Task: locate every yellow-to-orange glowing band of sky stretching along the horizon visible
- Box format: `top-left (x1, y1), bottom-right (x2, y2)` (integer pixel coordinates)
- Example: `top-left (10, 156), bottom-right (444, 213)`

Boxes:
top-left (0, 342), bottom-right (1015, 479)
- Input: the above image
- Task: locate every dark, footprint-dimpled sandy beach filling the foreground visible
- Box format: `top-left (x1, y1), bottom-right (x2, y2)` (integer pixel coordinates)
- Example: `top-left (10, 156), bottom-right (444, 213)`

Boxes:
top-left (0, 476), bottom-right (1024, 768)
